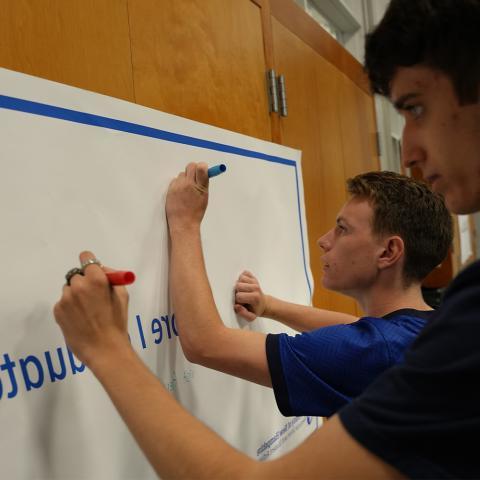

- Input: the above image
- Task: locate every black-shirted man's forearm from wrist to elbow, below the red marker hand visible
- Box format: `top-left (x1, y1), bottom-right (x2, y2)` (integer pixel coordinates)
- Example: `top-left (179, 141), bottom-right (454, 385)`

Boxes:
top-left (91, 345), bottom-right (254, 480)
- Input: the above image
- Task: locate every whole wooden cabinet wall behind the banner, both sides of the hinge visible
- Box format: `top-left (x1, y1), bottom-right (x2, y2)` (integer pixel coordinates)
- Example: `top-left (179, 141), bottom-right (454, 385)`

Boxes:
top-left (0, 0), bottom-right (378, 313)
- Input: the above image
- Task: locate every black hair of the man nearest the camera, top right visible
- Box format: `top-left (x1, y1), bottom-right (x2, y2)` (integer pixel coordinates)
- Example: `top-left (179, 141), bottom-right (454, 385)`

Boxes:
top-left (365, 0), bottom-right (480, 105)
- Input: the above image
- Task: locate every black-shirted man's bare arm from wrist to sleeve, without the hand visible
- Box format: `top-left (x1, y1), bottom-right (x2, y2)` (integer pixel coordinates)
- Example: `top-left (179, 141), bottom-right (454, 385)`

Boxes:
top-left (89, 343), bottom-right (401, 480)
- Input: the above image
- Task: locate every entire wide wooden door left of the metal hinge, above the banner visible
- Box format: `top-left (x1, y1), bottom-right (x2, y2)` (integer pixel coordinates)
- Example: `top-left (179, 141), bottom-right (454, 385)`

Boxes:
top-left (0, 0), bottom-right (271, 140)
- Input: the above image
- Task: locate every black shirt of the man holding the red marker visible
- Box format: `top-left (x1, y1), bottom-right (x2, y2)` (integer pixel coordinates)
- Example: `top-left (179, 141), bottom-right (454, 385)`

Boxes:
top-left (339, 262), bottom-right (480, 479)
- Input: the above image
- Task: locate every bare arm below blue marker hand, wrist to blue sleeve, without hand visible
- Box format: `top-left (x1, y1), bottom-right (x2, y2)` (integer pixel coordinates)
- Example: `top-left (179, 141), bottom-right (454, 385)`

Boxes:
top-left (170, 228), bottom-right (271, 386)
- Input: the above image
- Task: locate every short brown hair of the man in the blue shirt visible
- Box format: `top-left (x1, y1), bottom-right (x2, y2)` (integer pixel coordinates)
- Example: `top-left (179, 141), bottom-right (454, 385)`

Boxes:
top-left (347, 172), bottom-right (453, 285)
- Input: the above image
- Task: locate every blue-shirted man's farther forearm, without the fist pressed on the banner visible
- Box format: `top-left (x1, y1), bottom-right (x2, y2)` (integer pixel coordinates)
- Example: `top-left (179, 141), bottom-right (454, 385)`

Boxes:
top-left (263, 295), bottom-right (358, 332)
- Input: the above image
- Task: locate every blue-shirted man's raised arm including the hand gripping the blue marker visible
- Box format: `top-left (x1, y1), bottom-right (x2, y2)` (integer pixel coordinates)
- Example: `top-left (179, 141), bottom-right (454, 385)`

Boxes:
top-left (166, 163), bottom-right (271, 386)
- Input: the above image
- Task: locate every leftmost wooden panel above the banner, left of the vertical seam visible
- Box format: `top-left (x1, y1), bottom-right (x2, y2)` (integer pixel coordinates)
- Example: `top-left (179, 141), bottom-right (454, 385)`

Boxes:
top-left (0, 0), bottom-right (133, 101)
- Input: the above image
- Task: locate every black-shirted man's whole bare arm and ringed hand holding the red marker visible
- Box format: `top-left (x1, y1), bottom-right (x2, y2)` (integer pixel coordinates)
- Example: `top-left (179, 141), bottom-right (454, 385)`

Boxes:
top-left (54, 252), bottom-right (400, 480)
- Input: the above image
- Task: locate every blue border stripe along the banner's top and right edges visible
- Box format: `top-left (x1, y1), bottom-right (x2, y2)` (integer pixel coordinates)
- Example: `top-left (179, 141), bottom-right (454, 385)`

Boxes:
top-left (0, 91), bottom-right (312, 298)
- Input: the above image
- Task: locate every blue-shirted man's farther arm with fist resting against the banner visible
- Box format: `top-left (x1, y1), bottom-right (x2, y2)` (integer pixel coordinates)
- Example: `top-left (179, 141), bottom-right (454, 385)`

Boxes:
top-left (234, 271), bottom-right (358, 332)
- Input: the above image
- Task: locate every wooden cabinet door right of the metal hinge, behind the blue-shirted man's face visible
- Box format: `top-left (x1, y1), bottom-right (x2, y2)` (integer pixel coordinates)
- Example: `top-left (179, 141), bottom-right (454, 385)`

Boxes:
top-left (272, 18), bottom-right (356, 314)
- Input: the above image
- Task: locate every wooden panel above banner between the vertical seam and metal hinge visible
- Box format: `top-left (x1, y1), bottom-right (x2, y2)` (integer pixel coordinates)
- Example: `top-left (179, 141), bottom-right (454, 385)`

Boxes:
top-left (128, 0), bottom-right (271, 140)
